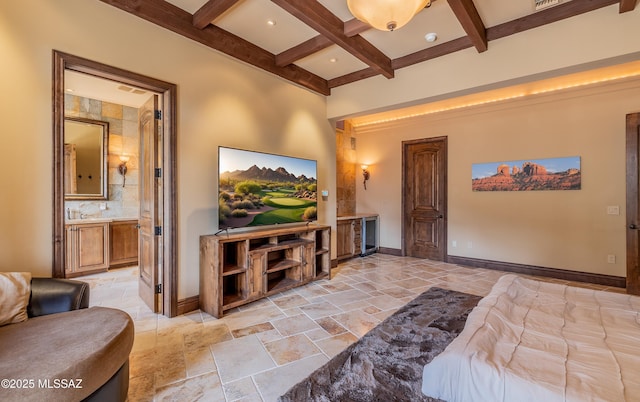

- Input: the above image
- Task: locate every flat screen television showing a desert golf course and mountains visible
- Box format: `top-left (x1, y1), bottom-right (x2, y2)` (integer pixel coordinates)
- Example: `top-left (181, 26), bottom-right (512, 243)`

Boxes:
top-left (218, 147), bottom-right (318, 230)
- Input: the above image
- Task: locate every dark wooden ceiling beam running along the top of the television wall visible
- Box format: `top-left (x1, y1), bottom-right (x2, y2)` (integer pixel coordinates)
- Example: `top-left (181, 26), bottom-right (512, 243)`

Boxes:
top-left (100, 0), bottom-right (331, 95)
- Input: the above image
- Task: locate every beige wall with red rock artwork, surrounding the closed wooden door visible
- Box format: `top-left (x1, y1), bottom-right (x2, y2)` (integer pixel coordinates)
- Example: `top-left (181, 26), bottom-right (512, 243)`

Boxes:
top-left (356, 78), bottom-right (640, 276)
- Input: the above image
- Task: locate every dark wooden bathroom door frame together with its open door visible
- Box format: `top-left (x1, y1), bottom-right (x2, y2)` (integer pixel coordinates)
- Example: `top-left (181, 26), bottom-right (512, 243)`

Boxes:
top-left (52, 51), bottom-right (178, 317)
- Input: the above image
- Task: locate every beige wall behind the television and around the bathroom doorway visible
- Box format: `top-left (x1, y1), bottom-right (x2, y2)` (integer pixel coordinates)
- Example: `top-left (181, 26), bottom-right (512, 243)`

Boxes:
top-left (0, 0), bottom-right (336, 299)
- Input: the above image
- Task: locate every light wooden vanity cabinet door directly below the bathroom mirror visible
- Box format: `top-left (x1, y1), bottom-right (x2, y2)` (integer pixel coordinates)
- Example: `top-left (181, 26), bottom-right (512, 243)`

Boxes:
top-left (74, 223), bottom-right (109, 272)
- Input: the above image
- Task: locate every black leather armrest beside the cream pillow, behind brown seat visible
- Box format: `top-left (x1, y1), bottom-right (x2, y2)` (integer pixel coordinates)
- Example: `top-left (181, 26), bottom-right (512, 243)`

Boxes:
top-left (27, 278), bottom-right (90, 318)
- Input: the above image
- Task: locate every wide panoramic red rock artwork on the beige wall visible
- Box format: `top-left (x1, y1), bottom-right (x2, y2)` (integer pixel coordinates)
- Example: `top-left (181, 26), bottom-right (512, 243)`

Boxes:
top-left (471, 156), bottom-right (581, 191)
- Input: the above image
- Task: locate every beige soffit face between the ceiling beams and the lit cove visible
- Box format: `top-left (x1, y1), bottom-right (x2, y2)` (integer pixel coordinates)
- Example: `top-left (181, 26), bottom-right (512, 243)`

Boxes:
top-left (327, 3), bottom-right (640, 120)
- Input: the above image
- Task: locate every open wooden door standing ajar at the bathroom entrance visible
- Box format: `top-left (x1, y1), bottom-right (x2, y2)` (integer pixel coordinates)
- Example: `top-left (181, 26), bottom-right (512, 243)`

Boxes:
top-left (138, 95), bottom-right (162, 313)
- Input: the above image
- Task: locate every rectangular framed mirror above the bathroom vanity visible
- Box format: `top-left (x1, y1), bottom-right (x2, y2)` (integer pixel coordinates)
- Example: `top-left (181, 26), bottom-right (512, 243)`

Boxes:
top-left (64, 117), bottom-right (109, 200)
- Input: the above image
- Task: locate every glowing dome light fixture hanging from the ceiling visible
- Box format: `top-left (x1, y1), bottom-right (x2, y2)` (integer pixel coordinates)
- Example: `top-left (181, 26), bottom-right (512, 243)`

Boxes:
top-left (347, 0), bottom-right (431, 31)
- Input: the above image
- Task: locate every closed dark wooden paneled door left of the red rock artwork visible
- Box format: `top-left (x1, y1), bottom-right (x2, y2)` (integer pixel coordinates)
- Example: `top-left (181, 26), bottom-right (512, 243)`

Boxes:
top-left (402, 137), bottom-right (447, 261)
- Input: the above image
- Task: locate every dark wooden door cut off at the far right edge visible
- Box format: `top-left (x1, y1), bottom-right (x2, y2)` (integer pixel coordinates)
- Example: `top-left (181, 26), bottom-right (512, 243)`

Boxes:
top-left (627, 113), bottom-right (640, 295)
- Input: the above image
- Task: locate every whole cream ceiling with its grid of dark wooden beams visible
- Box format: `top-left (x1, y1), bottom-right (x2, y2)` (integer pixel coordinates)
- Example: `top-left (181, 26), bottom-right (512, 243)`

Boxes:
top-left (101, 0), bottom-right (638, 95)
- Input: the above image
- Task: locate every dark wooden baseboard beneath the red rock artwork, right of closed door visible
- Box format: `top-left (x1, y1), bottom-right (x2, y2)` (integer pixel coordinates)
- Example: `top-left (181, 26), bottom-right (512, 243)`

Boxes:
top-left (447, 255), bottom-right (627, 288)
